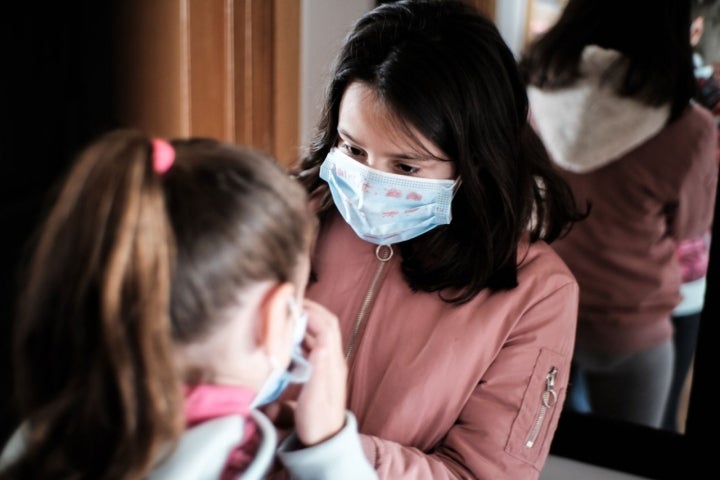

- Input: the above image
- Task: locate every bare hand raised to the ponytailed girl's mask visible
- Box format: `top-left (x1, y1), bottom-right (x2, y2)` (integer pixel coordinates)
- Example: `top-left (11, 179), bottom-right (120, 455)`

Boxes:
top-left (295, 300), bottom-right (347, 446)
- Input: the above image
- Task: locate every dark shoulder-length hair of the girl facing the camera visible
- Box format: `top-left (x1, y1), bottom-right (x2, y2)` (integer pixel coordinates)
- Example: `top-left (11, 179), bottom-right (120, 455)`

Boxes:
top-left (296, 0), bottom-right (581, 304)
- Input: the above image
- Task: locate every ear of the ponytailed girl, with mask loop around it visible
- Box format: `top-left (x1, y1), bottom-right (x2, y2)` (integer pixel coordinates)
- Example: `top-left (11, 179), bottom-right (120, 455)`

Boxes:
top-left (258, 282), bottom-right (295, 360)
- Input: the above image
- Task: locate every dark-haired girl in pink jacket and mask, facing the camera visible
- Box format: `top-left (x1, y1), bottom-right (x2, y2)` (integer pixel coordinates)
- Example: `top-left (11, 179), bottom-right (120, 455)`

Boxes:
top-left (278, 1), bottom-right (581, 479)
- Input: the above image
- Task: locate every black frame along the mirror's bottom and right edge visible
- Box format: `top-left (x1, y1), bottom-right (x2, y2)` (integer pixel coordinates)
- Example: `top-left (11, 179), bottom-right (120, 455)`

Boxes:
top-left (550, 189), bottom-right (720, 480)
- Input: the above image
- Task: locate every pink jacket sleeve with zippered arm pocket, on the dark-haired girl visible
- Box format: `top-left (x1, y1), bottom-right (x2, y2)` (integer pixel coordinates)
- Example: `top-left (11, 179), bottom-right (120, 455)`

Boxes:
top-left (360, 280), bottom-right (579, 480)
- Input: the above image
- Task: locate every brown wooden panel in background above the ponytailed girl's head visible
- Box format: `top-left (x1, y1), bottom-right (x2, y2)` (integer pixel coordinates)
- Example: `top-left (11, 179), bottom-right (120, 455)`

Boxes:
top-left (115, 0), bottom-right (301, 165)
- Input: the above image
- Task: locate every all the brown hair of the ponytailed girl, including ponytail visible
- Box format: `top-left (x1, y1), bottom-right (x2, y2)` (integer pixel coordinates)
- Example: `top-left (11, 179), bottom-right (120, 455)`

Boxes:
top-left (0, 131), bottom-right (312, 479)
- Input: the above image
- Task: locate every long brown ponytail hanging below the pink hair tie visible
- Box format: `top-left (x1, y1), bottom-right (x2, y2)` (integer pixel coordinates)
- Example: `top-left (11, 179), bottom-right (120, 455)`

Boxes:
top-left (5, 131), bottom-right (183, 479)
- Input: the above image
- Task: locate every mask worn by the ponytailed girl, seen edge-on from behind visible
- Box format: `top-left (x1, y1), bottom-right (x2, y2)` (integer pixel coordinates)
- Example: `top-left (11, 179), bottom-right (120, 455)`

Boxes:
top-left (250, 298), bottom-right (312, 408)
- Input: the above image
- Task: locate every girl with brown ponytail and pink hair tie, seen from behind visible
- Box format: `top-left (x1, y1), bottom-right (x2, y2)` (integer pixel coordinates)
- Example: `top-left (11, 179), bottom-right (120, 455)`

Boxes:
top-left (0, 131), bottom-right (376, 480)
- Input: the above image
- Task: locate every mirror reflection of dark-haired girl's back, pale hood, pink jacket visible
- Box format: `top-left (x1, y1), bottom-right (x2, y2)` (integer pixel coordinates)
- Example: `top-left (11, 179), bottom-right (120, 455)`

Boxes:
top-left (520, 0), bottom-right (717, 427)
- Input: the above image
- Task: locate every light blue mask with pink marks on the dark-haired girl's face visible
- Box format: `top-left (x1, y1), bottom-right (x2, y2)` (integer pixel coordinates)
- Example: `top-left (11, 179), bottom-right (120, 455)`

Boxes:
top-left (320, 148), bottom-right (459, 245)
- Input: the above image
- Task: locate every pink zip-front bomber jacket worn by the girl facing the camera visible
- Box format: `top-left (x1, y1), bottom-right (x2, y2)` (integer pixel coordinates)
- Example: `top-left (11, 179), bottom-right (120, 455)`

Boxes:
top-left (307, 213), bottom-right (578, 480)
